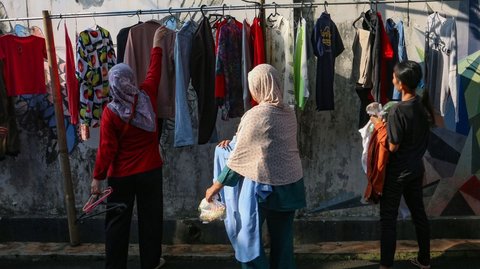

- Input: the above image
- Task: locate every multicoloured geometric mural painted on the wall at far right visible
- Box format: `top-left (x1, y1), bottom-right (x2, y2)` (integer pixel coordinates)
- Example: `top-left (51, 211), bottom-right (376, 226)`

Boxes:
top-left (312, 0), bottom-right (480, 217)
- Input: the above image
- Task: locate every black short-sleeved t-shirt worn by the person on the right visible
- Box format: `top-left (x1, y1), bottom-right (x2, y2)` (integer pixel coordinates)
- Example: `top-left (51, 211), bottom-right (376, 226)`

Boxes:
top-left (387, 96), bottom-right (430, 179)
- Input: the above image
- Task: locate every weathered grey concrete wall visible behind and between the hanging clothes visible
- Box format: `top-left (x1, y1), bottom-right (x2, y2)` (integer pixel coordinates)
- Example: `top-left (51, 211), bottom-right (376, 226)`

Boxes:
top-left (0, 0), bottom-right (480, 225)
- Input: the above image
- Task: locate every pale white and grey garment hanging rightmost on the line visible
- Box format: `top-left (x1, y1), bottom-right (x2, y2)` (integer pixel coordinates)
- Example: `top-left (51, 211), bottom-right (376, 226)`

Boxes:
top-left (425, 12), bottom-right (459, 122)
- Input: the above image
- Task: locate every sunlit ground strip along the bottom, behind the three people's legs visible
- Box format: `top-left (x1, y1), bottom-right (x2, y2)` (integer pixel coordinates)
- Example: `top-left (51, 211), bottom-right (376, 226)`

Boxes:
top-left (0, 239), bottom-right (480, 269)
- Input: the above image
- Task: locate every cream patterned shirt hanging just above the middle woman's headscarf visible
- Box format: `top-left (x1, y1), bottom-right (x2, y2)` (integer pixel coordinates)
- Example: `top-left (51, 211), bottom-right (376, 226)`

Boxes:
top-left (266, 16), bottom-right (295, 107)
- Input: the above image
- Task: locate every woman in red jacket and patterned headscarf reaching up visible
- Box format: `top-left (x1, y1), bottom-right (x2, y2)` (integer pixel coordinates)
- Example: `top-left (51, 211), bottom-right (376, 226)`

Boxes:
top-left (91, 29), bottom-right (164, 269)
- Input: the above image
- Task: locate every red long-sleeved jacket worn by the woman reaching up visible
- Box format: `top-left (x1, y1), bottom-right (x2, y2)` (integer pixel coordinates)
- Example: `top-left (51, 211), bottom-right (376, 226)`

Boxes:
top-left (93, 48), bottom-right (162, 180)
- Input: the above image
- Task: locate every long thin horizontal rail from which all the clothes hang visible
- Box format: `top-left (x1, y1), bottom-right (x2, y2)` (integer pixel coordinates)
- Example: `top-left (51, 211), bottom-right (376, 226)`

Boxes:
top-left (0, 0), bottom-right (458, 22)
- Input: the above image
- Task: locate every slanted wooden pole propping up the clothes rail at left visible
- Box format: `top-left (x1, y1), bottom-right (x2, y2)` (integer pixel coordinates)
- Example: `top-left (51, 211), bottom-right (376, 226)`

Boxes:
top-left (42, 10), bottom-right (80, 246)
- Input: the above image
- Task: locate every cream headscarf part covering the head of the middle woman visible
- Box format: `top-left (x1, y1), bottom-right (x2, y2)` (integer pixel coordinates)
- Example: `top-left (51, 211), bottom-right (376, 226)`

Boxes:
top-left (248, 64), bottom-right (283, 106)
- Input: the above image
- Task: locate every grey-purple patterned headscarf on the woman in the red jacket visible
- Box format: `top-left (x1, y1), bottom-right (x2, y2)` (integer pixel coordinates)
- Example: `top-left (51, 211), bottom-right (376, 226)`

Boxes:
top-left (108, 63), bottom-right (156, 132)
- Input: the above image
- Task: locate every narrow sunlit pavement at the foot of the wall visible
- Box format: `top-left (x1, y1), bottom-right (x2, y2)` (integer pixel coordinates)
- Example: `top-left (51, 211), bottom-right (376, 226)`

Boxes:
top-left (0, 239), bottom-right (480, 260)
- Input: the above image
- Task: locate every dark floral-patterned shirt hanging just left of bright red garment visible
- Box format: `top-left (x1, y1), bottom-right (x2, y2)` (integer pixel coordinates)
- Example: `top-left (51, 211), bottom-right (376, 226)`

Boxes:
top-left (215, 19), bottom-right (244, 119)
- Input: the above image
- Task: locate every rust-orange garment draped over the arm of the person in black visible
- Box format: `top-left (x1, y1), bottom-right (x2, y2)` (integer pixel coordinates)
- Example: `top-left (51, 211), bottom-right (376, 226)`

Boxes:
top-left (363, 122), bottom-right (389, 203)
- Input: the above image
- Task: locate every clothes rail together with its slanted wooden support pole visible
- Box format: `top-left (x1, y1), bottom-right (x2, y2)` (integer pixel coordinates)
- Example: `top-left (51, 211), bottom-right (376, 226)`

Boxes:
top-left (0, 0), bottom-right (458, 246)
